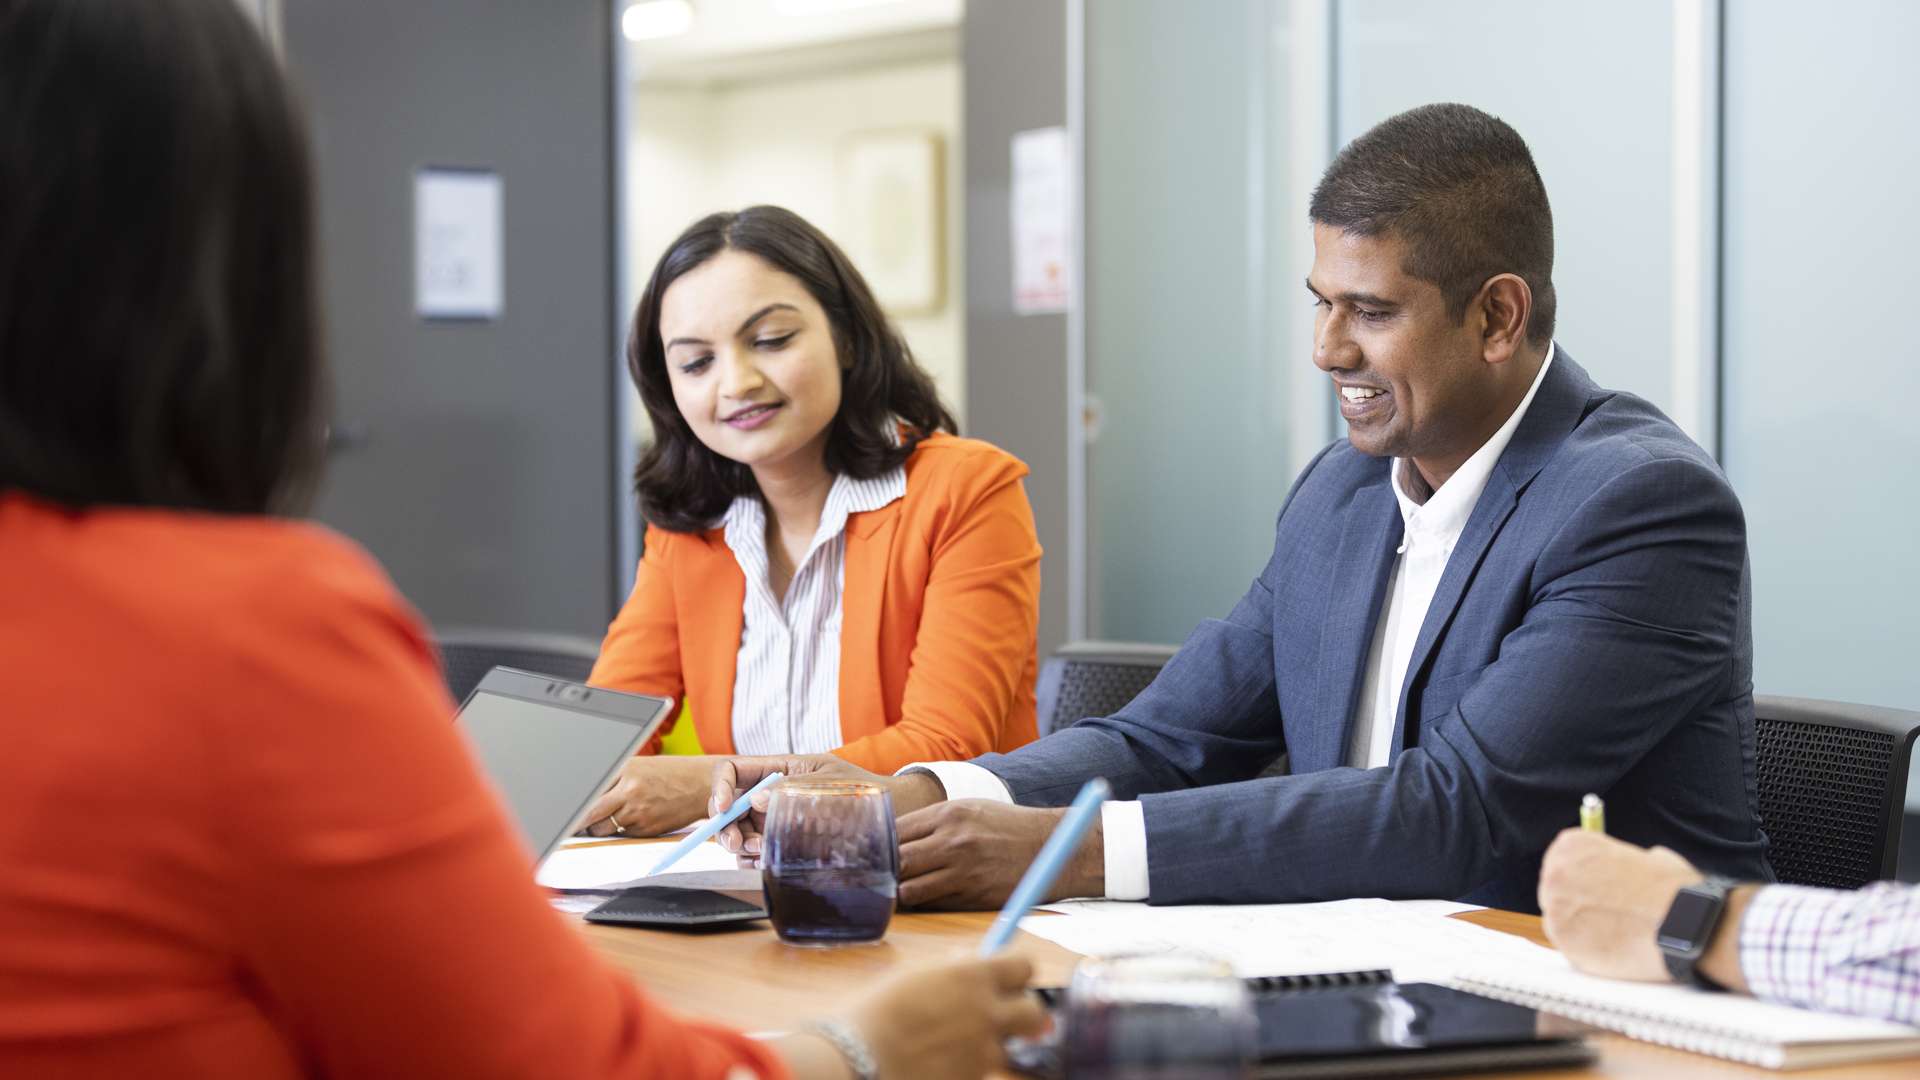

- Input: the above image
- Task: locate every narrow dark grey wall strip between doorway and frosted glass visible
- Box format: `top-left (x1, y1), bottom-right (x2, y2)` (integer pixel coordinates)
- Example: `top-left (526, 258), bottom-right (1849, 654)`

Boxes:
top-left (960, 0), bottom-right (1068, 655)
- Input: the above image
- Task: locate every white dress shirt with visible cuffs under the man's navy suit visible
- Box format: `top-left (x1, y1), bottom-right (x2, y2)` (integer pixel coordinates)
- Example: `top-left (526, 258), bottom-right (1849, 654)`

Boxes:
top-left (902, 342), bottom-right (1553, 899)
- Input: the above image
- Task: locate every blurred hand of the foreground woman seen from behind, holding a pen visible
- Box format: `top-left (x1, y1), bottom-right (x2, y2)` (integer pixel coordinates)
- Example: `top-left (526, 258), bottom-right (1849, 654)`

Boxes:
top-left (780, 955), bottom-right (1046, 1080)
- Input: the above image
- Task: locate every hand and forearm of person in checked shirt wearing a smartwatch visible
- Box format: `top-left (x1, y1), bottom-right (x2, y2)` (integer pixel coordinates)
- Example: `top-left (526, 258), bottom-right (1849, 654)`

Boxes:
top-left (1540, 828), bottom-right (1920, 1024)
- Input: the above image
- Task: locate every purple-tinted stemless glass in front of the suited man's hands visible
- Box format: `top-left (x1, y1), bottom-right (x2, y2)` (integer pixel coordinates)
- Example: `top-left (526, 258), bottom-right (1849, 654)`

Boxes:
top-left (760, 780), bottom-right (900, 945)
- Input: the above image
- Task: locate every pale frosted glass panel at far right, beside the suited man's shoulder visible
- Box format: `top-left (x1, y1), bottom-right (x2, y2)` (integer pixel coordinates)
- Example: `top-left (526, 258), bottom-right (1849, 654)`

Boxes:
top-left (1724, 0), bottom-right (1920, 718)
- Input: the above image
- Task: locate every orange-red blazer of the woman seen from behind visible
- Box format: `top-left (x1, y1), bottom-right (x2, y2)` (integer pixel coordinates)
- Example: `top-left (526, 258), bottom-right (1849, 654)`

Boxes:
top-left (0, 492), bottom-right (787, 1080)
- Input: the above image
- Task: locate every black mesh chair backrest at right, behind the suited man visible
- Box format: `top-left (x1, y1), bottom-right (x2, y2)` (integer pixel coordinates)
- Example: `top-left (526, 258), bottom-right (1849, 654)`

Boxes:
top-left (1753, 696), bottom-right (1920, 888)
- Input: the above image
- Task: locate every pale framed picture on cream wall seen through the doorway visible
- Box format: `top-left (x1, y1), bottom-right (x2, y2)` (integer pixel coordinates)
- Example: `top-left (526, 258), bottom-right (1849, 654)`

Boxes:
top-left (839, 131), bottom-right (947, 315)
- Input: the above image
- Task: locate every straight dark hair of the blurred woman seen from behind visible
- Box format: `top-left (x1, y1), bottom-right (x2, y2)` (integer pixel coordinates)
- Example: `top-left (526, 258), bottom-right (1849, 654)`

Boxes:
top-left (0, 0), bottom-right (321, 513)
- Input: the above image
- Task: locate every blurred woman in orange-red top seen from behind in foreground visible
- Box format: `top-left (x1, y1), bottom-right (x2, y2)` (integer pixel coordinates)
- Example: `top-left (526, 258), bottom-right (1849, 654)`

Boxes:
top-left (0, 0), bottom-right (1041, 1080)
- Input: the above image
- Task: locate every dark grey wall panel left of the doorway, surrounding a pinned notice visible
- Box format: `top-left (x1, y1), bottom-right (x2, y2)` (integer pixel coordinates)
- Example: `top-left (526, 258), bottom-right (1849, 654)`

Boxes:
top-left (284, 0), bottom-right (614, 636)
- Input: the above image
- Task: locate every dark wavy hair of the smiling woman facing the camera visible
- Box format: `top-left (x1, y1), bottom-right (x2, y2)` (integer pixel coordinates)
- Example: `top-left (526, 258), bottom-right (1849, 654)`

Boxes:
top-left (626, 206), bottom-right (958, 532)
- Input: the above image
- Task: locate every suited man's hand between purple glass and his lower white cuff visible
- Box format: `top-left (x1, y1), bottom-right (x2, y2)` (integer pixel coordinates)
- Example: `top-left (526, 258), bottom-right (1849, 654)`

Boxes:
top-left (899, 799), bottom-right (1106, 911)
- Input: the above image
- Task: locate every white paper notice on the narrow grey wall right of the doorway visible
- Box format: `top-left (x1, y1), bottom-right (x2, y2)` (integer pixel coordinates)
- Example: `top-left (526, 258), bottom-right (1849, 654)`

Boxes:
top-left (1010, 127), bottom-right (1073, 315)
